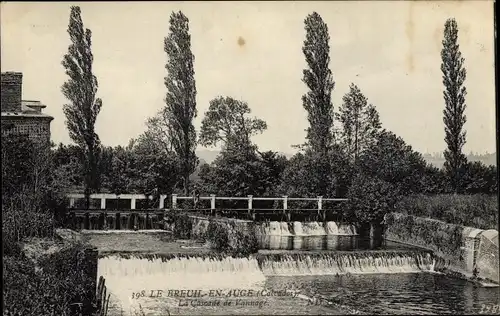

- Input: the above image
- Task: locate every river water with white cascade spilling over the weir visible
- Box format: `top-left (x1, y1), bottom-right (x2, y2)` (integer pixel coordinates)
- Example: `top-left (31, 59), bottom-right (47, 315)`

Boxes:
top-left (91, 228), bottom-right (500, 316)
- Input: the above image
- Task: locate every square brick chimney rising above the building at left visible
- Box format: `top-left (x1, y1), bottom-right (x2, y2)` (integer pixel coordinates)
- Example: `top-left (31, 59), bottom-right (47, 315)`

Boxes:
top-left (1, 72), bottom-right (23, 112)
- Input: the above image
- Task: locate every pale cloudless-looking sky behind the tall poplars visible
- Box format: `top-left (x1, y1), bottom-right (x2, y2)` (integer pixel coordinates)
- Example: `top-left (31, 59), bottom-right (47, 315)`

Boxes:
top-left (1, 1), bottom-right (496, 153)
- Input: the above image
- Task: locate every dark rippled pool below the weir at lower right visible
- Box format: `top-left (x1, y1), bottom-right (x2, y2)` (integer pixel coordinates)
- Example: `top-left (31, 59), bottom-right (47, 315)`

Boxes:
top-left (266, 273), bottom-right (500, 315)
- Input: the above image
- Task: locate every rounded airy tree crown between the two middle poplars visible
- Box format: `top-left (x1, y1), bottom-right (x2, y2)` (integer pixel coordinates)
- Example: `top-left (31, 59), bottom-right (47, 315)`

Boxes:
top-left (200, 97), bottom-right (267, 147)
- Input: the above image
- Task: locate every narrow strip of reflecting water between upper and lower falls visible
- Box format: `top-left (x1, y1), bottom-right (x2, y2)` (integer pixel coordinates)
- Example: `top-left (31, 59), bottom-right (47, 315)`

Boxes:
top-left (258, 235), bottom-right (414, 251)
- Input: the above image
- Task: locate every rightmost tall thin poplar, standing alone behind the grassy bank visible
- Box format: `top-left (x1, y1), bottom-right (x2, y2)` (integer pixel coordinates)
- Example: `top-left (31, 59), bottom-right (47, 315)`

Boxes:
top-left (441, 19), bottom-right (467, 192)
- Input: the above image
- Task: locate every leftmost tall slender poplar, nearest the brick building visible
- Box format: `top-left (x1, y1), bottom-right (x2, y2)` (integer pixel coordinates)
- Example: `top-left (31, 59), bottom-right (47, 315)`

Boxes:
top-left (61, 6), bottom-right (102, 206)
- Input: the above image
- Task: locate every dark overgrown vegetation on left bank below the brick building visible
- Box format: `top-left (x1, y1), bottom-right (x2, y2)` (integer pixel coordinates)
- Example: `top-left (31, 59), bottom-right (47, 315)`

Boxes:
top-left (2, 136), bottom-right (99, 316)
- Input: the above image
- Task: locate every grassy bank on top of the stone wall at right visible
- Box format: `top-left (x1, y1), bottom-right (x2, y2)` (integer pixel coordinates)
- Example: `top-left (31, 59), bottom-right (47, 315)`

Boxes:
top-left (395, 194), bottom-right (498, 230)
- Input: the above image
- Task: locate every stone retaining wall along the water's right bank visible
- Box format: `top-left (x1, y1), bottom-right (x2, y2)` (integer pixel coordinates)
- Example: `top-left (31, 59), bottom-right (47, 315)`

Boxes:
top-left (384, 213), bottom-right (499, 283)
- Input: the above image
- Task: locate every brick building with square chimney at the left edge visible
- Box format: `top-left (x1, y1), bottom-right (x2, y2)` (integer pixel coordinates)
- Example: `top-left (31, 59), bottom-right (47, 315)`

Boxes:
top-left (1, 72), bottom-right (54, 143)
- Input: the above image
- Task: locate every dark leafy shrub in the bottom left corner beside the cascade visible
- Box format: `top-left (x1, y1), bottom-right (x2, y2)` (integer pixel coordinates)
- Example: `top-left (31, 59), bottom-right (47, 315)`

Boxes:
top-left (3, 245), bottom-right (96, 316)
